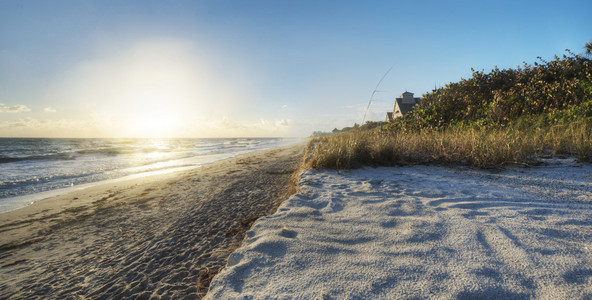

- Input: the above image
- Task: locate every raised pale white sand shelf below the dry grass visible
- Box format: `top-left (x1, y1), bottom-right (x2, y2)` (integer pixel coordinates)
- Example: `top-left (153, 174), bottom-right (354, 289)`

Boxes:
top-left (207, 159), bottom-right (592, 299)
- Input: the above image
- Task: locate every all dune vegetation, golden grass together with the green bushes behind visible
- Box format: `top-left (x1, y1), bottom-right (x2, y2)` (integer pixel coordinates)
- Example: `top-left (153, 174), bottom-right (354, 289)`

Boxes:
top-left (306, 44), bottom-right (592, 168)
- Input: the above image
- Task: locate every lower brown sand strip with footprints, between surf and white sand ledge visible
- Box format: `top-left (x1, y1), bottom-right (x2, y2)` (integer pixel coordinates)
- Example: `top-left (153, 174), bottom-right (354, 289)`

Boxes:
top-left (0, 144), bottom-right (304, 299)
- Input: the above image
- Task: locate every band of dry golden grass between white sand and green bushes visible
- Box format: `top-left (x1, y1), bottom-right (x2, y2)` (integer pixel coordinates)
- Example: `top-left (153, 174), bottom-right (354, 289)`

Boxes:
top-left (306, 120), bottom-right (592, 169)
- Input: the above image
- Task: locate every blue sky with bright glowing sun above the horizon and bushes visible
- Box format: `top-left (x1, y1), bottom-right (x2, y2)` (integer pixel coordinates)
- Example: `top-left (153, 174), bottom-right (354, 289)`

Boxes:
top-left (0, 0), bottom-right (592, 137)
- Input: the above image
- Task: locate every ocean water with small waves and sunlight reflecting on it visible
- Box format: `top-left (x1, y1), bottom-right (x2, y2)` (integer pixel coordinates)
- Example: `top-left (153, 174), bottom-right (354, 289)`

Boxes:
top-left (0, 138), bottom-right (299, 212)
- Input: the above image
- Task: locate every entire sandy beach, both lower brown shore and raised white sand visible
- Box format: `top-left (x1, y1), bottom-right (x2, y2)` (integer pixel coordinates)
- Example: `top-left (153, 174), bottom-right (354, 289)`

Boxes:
top-left (0, 144), bottom-right (592, 299)
